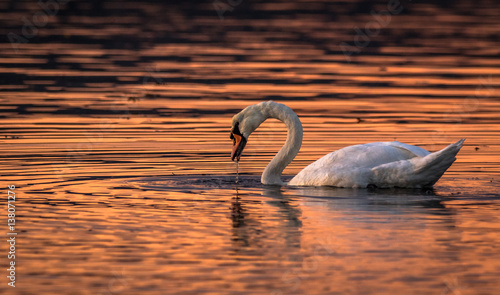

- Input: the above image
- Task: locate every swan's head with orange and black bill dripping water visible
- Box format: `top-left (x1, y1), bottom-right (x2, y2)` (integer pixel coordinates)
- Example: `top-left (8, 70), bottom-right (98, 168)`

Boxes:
top-left (230, 102), bottom-right (268, 162)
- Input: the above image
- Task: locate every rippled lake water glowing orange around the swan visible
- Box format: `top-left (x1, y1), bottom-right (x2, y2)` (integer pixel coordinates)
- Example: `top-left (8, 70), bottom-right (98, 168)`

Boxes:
top-left (0, 1), bottom-right (500, 294)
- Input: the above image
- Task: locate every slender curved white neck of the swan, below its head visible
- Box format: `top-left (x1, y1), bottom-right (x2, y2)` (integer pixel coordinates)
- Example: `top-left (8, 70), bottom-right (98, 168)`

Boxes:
top-left (261, 103), bottom-right (302, 185)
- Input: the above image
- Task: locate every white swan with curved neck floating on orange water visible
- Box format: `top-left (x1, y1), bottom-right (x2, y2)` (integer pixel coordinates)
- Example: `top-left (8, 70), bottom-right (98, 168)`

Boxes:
top-left (230, 101), bottom-right (465, 188)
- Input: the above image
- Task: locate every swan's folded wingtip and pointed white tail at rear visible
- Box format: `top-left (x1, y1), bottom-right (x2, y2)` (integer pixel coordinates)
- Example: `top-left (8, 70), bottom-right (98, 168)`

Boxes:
top-left (372, 138), bottom-right (465, 187)
